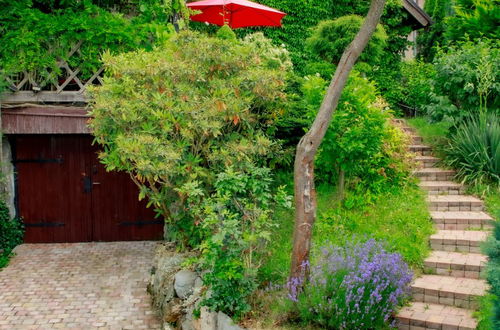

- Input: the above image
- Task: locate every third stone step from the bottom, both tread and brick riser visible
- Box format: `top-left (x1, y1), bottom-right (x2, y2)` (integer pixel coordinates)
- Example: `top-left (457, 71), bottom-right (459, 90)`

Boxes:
top-left (424, 251), bottom-right (488, 278)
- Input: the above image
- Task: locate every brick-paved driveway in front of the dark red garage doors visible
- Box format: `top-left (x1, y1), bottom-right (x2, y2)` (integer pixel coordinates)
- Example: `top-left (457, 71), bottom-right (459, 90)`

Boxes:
top-left (0, 242), bottom-right (160, 330)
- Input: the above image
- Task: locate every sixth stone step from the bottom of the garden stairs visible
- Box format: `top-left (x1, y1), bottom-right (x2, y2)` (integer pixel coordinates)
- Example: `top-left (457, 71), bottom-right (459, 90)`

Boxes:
top-left (427, 195), bottom-right (484, 211)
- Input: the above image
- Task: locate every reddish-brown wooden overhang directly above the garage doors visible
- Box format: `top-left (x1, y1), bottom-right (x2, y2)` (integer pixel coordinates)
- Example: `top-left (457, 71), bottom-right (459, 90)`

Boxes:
top-left (2, 105), bottom-right (91, 134)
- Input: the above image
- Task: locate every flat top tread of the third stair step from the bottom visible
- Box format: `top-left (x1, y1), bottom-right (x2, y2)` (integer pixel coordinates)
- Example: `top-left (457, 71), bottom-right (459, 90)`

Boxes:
top-left (425, 251), bottom-right (488, 271)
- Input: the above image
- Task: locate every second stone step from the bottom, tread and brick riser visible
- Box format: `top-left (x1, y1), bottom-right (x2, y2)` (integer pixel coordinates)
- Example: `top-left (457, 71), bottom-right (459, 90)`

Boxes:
top-left (411, 275), bottom-right (488, 309)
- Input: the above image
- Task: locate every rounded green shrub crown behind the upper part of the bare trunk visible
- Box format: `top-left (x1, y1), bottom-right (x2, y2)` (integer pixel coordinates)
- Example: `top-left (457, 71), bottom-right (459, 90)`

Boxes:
top-left (306, 15), bottom-right (387, 64)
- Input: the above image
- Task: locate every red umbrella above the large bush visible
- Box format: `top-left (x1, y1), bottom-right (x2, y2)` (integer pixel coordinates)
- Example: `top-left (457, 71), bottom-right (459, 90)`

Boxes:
top-left (187, 0), bottom-right (286, 29)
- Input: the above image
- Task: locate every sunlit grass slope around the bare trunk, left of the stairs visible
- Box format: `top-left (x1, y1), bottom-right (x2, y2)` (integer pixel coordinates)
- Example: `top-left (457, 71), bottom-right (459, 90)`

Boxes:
top-left (259, 179), bottom-right (434, 284)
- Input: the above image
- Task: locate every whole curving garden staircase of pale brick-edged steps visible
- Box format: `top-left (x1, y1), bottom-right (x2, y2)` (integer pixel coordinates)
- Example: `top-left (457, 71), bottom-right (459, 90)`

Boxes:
top-left (396, 120), bottom-right (493, 330)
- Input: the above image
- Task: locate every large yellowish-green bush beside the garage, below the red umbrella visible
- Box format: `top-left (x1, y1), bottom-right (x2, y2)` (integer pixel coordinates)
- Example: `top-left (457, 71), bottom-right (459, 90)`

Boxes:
top-left (91, 31), bottom-right (291, 246)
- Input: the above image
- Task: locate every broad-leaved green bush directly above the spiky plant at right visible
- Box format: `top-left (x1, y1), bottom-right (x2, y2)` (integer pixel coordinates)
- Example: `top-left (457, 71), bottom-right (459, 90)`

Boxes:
top-left (426, 40), bottom-right (500, 122)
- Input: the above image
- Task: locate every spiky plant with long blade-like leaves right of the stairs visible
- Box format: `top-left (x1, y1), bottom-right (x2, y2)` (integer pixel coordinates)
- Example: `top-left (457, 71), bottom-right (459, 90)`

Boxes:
top-left (446, 113), bottom-right (500, 183)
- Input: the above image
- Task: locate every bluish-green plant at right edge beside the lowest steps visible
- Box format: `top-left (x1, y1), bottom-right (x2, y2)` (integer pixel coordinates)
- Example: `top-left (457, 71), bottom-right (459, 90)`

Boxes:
top-left (484, 218), bottom-right (500, 329)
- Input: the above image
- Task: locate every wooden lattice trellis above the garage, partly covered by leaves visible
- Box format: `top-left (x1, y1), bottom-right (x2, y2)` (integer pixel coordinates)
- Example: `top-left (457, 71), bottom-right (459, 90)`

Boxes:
top-left (0, 41), bottom-right (104, 103)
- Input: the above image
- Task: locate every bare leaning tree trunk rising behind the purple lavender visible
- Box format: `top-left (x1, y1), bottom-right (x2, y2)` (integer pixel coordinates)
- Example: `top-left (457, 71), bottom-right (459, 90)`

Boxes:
top-left (290, 0), bottom-right (385, 278)
